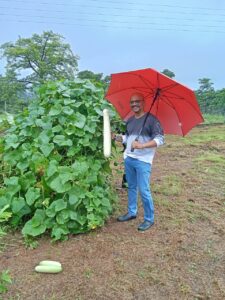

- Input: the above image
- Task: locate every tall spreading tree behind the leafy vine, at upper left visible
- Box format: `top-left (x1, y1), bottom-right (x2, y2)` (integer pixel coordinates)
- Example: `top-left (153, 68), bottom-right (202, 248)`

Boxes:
top-left (0, 31), bottom-right (79, 86)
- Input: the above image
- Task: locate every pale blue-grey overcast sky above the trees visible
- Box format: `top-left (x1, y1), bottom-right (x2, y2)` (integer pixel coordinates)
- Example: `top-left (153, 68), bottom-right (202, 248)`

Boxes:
top-left (0, 0), bottom-right (225, 89)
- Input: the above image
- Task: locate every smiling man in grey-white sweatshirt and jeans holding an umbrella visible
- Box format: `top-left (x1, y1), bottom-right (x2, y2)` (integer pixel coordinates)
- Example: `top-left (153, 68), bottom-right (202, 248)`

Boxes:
top-left (117, 93), bottom-right (164, 231)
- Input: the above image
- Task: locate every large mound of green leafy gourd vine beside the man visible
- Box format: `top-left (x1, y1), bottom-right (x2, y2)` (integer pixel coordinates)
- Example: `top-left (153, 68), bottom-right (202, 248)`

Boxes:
top-left (0, 79), bottom-right (119, 240)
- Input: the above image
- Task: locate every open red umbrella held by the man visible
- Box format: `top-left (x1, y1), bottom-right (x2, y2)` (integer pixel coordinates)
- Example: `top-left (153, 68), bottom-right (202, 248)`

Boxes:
top-left (105, 68), bottom-right (204, 136)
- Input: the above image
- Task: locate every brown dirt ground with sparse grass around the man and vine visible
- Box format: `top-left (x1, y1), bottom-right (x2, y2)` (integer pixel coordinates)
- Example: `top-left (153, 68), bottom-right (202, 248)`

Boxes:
top-left (0, 126), bottom-right (225, 300)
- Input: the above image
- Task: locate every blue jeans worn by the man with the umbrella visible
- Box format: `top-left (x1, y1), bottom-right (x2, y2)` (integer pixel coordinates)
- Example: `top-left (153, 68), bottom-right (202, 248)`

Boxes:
top-left (125, 156), bottom-right (154, 223)
